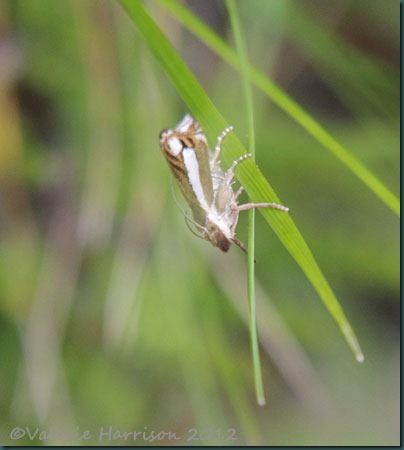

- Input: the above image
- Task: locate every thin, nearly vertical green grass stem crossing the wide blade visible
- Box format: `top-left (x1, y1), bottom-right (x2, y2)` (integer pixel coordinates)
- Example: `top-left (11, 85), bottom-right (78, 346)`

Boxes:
top-left (226, 0), bottom-right (266, 406)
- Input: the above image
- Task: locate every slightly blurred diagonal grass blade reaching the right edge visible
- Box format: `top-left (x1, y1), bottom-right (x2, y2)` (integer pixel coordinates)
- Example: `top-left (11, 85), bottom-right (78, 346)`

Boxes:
top-left (159, 0), bottom-right (400, 216)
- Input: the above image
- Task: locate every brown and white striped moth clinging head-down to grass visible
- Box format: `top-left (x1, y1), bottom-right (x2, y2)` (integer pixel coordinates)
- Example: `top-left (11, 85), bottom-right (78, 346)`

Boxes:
top-left (160, 114), bottom-right (289, 253)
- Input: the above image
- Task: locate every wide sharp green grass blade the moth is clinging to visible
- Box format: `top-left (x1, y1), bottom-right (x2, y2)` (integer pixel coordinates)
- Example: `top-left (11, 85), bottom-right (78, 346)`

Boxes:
top-left (121, 0), bottom-right (363, 361)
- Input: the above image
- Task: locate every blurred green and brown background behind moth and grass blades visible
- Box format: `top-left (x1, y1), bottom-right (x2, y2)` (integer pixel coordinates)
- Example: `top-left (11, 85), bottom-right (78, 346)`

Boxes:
top-left (0, 0), bottom-right (400, 446)
